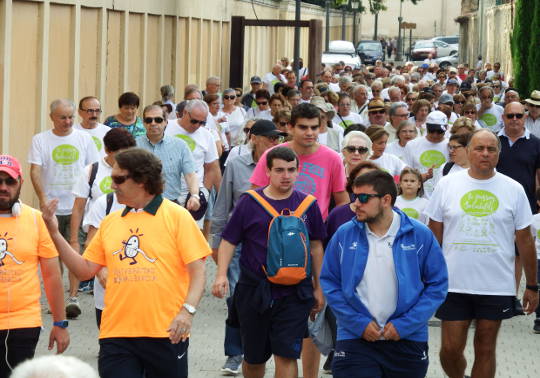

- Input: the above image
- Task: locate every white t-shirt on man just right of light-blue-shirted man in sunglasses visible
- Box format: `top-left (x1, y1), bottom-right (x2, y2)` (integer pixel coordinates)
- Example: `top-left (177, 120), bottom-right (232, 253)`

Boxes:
top-left (165, 122), bottom-right (219, 192)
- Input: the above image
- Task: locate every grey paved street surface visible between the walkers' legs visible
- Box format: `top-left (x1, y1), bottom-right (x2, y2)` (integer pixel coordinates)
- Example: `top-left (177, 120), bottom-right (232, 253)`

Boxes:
top-left (36, 259), bottom-right (540, 378)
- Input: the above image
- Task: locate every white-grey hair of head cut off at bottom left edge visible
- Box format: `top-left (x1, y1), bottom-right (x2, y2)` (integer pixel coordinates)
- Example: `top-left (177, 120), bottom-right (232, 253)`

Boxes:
top-left (10, 355), bottom-right (99, 378)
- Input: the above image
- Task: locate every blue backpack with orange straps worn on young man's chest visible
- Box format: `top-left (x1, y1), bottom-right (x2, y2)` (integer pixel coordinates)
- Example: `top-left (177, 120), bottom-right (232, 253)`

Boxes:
top-left (246, 190), bottom-right (315, 285)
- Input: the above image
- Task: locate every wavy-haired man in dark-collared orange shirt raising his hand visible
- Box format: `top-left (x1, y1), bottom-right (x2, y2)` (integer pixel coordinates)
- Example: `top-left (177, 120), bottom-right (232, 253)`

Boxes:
top-left (43, 148), bottom-right (211, 378)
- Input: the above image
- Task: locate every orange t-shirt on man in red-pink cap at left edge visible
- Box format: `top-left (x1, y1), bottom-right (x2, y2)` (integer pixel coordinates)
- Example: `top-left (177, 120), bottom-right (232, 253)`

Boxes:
top-left (0, 204), bottom-right (58, 329)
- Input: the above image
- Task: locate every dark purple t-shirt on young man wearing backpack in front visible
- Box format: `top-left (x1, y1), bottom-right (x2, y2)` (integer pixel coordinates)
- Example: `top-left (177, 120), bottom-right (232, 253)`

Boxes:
top-left (221, 188), bottom-right (326, 284)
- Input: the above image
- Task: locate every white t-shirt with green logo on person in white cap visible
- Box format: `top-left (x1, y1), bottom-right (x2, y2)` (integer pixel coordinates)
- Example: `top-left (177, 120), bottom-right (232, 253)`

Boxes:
top-left (405, 137), bottom-right (448, 198)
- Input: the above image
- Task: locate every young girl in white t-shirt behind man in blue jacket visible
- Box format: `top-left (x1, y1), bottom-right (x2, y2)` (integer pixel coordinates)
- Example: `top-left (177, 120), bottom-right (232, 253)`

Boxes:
top-left (396, 167), bottom-right (428, 224)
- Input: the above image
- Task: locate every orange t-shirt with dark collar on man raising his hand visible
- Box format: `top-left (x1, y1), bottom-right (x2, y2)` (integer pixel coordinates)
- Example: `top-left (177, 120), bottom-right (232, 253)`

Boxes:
top-left (83, 199), bottom-right (211, 338)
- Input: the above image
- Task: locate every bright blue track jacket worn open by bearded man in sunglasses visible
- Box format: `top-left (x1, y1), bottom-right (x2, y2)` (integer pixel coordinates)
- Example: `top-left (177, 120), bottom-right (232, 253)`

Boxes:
top-left (320, 208), bottom-right (448, 342)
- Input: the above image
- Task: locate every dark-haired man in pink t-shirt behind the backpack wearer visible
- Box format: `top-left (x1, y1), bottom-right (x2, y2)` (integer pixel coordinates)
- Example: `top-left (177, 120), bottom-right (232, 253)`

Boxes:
top-left (250, 103), bottom-right (350, 378)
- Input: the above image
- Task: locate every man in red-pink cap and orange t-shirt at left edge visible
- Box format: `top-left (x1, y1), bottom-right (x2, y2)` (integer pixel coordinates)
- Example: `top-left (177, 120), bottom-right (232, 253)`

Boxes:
top-left (0, 155), bottom-right (69, 378)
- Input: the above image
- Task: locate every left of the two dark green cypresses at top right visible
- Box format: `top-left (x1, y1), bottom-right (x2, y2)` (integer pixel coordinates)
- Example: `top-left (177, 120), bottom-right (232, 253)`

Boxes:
top-left (510, 0), bottom-right (540, 95)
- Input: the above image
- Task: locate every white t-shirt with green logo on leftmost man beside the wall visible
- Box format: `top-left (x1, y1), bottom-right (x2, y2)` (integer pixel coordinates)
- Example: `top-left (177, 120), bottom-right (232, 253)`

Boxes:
top-left (28, 129), bottom-right (99, 215)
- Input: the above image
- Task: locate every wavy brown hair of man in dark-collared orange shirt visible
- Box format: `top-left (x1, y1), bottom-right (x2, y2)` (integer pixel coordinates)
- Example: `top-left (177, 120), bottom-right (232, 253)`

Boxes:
top-left (116, 147), bottom-right (163, 195)
